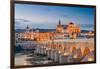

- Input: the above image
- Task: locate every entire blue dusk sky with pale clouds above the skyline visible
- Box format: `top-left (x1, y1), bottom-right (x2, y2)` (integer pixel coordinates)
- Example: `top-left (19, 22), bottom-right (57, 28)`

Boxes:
top-left (15, 4), bottom-right (95, 30)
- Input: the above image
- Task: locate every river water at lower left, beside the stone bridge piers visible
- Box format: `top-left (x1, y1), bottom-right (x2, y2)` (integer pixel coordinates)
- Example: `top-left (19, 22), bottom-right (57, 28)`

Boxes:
top-left (15, 46), bottom-right (53, 66)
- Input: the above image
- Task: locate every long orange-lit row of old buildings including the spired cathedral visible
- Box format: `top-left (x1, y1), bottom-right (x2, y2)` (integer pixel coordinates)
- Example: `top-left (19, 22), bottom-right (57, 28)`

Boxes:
top-left (15, 20), bottom-right (93, 41)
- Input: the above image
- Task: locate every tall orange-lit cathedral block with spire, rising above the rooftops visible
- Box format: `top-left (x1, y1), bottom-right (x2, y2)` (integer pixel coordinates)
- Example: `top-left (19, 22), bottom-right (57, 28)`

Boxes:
top-left (56, 20), bottom-right (81, 39)
